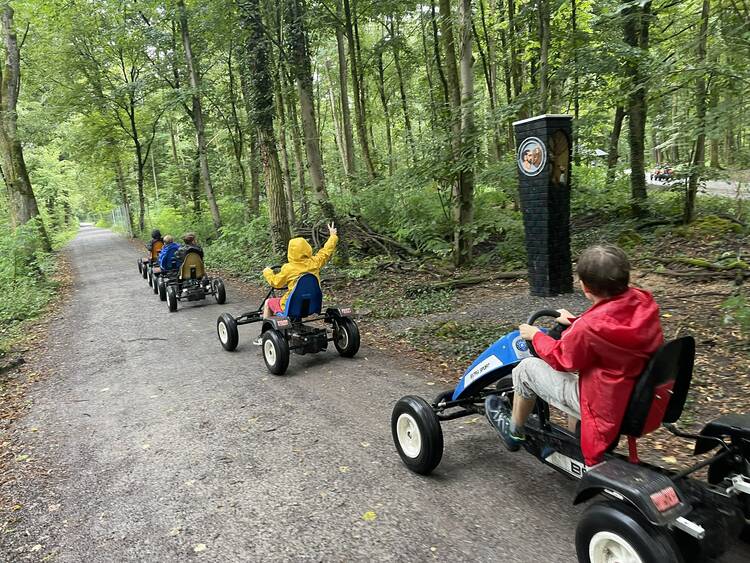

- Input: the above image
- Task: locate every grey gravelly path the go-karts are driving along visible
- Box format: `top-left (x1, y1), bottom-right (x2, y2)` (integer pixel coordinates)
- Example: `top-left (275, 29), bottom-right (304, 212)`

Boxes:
top-left (0, 227), bottom-right (750, 562)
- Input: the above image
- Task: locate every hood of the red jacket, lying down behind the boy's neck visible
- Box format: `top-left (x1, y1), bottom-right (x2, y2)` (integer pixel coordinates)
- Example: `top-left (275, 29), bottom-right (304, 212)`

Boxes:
top-left (587, 287), bottom-right (661, 350)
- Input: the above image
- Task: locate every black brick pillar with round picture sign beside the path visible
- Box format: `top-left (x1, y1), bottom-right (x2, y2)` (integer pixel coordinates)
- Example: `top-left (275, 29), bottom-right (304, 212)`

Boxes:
top-left (513, 115), bottom-right (573, 297)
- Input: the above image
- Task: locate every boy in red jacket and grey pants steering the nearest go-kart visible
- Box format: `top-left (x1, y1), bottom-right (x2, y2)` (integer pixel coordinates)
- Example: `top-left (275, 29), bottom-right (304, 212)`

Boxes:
top-left (485, 245), bottom-right (664, 466)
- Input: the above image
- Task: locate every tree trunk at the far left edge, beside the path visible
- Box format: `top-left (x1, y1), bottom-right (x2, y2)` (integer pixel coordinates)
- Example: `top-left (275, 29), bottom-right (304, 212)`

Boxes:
top-left (0, 3), bottom-right (52, 252)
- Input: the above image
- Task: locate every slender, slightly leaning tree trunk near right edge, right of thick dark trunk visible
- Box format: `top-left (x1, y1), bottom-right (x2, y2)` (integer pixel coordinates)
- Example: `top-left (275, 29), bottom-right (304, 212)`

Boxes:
top-left (682, 0), bottom-right (710, 223)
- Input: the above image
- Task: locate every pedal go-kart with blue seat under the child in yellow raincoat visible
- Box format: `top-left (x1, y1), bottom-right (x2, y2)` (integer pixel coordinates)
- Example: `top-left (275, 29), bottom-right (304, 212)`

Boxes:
top-left (216, 274), bottom-right (359, 375)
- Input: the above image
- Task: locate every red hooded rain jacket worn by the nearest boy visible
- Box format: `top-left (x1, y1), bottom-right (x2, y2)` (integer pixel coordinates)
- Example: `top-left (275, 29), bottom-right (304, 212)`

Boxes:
top-left (533, 287), bottom-right (664, 467)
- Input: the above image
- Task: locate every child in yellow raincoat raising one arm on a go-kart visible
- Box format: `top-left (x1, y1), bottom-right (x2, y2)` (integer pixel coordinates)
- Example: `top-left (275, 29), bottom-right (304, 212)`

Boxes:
top-left (263, 223), bottom-right (339, 318)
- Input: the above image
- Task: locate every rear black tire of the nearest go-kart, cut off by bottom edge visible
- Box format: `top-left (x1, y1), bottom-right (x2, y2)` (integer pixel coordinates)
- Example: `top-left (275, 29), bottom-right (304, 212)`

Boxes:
top-left (576, 501), bottom-right (683, 563)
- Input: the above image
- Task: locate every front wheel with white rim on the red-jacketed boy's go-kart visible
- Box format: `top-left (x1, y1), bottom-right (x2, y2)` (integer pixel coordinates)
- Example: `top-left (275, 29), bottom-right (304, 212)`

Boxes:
top-left (391, 395), bottom-right (443, 475)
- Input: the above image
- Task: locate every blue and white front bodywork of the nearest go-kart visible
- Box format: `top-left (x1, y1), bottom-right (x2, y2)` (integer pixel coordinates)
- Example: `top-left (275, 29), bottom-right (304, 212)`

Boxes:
top-left (451, 329), bottom-right (546, 401)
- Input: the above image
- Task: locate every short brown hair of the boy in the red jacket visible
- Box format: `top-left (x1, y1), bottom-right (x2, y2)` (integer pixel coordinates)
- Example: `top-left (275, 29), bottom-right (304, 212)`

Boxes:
top-left (576, 244), bottom-right (630, 297)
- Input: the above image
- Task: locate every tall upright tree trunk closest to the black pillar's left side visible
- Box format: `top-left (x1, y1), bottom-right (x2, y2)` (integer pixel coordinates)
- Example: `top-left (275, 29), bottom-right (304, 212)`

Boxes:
top-left (453, 0), bottom-right (476, 266)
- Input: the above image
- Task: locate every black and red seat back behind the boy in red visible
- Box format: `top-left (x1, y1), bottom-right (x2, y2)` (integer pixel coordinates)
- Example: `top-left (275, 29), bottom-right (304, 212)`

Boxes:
top-left (620, 336), bottom-right (695, 463)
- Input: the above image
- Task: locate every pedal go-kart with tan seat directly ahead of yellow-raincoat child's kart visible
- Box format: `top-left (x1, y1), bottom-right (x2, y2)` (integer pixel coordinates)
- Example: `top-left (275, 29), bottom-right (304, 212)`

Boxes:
top-left (162, 251), bottom-right (227, 313)
